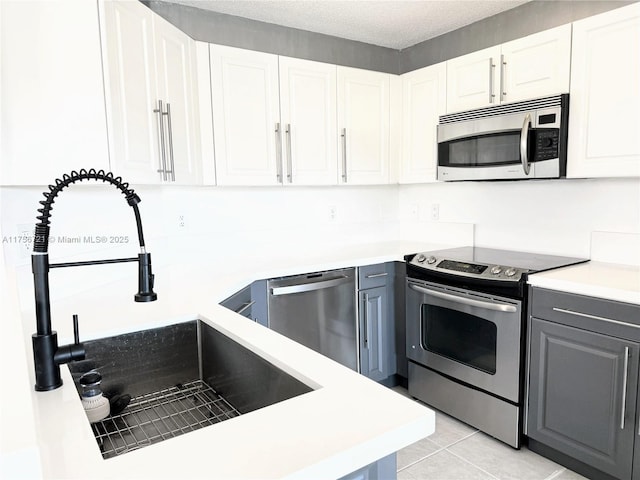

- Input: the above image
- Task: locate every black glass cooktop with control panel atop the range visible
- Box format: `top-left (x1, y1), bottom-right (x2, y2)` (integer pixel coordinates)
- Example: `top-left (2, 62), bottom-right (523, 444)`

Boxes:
top-left (407, 247), bottom-right (587, 282)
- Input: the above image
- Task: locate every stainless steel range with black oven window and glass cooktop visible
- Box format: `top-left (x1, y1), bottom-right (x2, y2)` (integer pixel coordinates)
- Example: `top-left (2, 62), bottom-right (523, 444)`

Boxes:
top-left (405, 247), bottom-right (586, 448)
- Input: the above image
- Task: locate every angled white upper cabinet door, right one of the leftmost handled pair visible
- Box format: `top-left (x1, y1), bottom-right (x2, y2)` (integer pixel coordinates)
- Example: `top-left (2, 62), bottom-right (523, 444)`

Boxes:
top-left (153, 15), bottom-right (201, 185)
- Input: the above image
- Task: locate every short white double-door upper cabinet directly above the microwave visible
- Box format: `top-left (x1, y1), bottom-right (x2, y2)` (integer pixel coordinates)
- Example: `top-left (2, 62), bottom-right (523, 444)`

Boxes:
top-left (447, 25), bottom-right (571, 113)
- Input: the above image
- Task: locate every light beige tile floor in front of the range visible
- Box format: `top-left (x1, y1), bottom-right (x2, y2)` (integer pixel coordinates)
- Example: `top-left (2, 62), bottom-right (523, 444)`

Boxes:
top-left (394, 387), bottom-right (584, 480)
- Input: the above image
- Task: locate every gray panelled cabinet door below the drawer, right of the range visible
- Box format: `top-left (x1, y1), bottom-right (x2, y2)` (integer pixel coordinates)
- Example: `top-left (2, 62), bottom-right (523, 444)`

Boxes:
top-left (528, 318), bottom-right (640, 479)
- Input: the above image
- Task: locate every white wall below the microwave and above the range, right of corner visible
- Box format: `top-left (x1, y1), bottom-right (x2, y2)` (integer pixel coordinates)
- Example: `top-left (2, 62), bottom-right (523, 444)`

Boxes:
top-left (398, 178), bottom-right (640, 258)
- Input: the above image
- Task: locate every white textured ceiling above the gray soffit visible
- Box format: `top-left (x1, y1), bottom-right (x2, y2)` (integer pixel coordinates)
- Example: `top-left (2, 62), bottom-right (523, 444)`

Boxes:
top-left (162, 0), bottom-right (529, 50)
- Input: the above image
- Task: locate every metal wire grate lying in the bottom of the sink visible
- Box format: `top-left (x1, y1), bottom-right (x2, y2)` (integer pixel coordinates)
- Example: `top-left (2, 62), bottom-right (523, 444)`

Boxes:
top-left (91, 380), bottom-right (240, 459)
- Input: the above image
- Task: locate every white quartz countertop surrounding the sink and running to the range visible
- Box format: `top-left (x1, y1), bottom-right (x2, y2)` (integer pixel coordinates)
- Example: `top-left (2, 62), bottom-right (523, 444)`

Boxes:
top-left (17, 242), bottom-right (447, 479)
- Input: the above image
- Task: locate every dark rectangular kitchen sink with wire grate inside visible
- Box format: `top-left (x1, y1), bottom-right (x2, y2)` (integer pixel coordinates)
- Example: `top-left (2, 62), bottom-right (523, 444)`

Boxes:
top-left (69, 320), bottom-right (313, 459)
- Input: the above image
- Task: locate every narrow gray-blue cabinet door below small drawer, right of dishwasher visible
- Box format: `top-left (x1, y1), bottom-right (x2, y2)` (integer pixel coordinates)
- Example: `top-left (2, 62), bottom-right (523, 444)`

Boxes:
top-left (360, 286), bottom-right (395, 381)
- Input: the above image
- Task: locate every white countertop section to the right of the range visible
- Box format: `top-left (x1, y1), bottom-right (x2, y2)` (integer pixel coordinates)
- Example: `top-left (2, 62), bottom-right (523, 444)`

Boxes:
top-left (528, 261), bottom-right (640, 305)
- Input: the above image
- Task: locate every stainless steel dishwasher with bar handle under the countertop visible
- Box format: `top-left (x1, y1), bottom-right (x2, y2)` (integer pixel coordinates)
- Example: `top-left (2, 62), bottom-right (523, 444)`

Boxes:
top-left (267, 268), bottom-right (358, 371)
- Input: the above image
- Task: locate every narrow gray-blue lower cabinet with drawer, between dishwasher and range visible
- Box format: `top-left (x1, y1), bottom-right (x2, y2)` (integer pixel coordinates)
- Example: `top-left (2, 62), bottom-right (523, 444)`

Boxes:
top-left (358, 263), bottom-right (396, 382)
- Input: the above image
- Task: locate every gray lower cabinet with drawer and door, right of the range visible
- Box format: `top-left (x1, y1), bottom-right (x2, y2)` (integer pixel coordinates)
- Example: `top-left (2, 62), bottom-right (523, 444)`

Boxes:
top-left (527, 288), bottom-right (640, 480)
